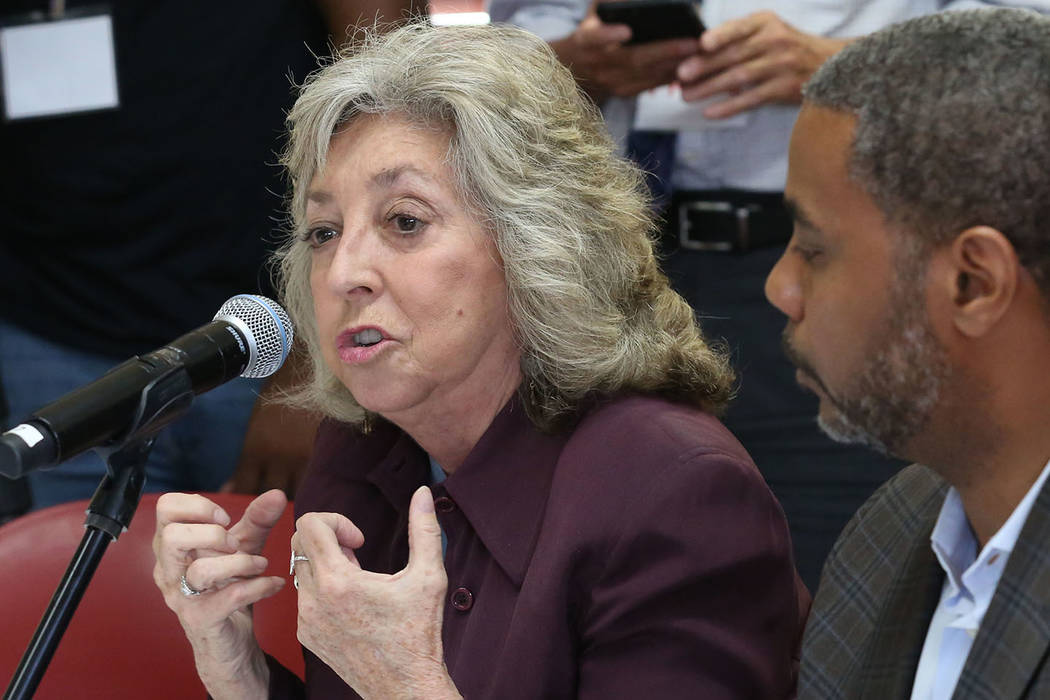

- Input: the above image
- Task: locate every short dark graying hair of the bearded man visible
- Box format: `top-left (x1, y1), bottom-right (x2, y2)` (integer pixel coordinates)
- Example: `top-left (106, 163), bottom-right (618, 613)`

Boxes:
top-left (802, 9), bottom-right (1050, 296)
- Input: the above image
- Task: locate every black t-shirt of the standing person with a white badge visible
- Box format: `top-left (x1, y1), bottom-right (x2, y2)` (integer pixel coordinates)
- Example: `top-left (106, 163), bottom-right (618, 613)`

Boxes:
top-left (0, 0), bottom-right (327, 358)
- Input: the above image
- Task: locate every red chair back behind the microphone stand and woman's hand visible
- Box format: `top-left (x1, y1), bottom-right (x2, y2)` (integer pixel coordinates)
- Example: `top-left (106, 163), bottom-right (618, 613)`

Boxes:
top-left (0, 493), bottom-right (302, 700)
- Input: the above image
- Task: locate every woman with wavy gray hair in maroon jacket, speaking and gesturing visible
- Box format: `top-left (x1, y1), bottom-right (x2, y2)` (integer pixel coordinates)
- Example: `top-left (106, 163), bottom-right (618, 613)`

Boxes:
top-left (155, 19), bottom-right (809, 699)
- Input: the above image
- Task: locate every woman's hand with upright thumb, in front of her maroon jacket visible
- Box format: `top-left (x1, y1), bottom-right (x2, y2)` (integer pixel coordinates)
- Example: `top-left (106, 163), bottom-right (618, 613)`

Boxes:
top-left (292, 486), bottom-right (460, 699)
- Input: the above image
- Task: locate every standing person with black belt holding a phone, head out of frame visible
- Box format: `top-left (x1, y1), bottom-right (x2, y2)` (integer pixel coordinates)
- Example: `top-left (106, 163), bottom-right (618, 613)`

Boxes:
top-left (489, 0), bottom-right (1050, 589)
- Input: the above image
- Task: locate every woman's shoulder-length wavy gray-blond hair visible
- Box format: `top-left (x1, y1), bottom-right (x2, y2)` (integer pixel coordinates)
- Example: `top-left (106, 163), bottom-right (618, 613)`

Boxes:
top-left (276, 23), bottom-right (733, 429)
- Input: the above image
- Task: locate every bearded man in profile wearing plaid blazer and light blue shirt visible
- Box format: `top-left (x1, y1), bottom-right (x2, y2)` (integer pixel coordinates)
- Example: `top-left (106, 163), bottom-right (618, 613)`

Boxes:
top-left (765, 9), bottom-right (1050, 700)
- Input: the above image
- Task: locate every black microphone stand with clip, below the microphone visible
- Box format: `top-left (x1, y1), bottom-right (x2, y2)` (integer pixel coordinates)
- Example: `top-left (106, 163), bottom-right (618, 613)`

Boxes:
top-left (3, 367), bottom-right (194, 700)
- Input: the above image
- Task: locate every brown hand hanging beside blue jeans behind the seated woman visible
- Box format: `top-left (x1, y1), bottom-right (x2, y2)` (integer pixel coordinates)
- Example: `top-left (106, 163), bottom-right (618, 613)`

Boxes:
top-left (221, 395), bottom-right (320, 499)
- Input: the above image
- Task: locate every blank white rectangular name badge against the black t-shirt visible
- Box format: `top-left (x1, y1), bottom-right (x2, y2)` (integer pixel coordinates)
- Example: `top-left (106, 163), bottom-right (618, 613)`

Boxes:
top-left (0, 15), bottom-right (120, 120)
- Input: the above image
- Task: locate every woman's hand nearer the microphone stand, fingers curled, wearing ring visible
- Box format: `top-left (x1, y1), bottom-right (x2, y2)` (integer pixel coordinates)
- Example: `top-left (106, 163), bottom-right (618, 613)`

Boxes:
top-left (153, 489), bottom-right (288, 700)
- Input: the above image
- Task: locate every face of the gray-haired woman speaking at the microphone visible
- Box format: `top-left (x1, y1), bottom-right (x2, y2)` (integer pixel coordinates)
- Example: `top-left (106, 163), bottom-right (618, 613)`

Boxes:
top-left (306, 115), bottom-right (520, 426)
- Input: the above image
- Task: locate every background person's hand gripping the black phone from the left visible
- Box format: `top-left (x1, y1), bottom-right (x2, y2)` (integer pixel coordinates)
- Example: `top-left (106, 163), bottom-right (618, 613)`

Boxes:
top-left (550, 5), bottom-right (696, 102)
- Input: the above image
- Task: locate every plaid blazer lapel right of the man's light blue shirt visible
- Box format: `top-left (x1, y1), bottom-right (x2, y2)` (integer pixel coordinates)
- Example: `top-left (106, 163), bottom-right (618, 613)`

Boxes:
top-left (953, 480), bottom-right (1050, 698)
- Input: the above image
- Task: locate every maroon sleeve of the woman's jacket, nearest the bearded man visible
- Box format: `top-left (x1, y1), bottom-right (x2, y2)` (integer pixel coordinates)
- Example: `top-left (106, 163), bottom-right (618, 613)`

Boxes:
top-left (578, 454), bottom-right (810, 700)
